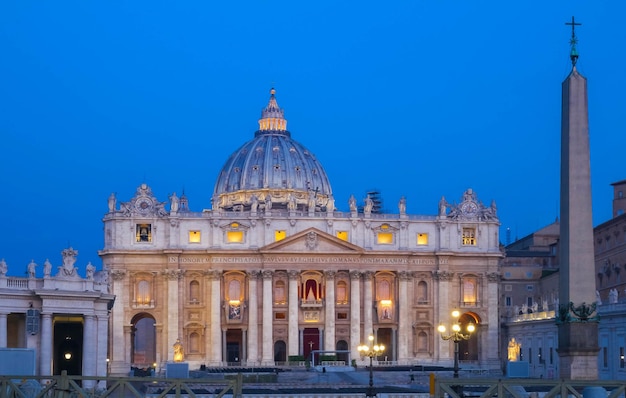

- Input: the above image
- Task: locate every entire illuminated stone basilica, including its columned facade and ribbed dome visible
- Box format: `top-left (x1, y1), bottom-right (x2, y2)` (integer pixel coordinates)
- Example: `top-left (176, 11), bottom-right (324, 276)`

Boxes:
top-left (100, 90), bottom-right (502, 374)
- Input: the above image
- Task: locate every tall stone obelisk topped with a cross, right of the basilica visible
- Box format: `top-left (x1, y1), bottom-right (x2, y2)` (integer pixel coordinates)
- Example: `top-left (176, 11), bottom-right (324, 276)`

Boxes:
top-left (556, 17), bottom-right (599, 380)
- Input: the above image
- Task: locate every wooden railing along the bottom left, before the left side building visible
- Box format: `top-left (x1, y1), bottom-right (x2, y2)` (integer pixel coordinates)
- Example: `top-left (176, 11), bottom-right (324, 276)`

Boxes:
top-left (0, 371), bottom-right (243, 398)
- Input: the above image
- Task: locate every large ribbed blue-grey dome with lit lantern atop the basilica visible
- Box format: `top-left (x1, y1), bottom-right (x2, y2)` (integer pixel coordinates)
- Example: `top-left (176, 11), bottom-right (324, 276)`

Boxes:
top-left (213, 89), bottom-right (334, 212)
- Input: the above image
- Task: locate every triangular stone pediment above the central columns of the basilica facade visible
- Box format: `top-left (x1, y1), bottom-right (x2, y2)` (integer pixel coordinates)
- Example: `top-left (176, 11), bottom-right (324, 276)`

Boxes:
top-left (260, 228), bottom-right (363, 254)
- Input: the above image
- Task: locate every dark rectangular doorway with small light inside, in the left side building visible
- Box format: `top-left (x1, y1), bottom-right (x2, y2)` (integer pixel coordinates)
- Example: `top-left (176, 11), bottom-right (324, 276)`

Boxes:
top-left (53, 321), bottom-right (83, 376)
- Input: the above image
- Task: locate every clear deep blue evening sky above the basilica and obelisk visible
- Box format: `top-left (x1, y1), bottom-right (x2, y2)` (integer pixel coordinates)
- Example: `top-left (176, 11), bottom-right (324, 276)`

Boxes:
top-left (0, 0), bottom-right (626, 275)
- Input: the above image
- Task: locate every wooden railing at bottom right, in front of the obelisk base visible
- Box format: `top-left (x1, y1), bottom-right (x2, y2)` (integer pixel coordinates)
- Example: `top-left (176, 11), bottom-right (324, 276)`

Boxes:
top-left (434, 378), bottom-right (626, 398)
